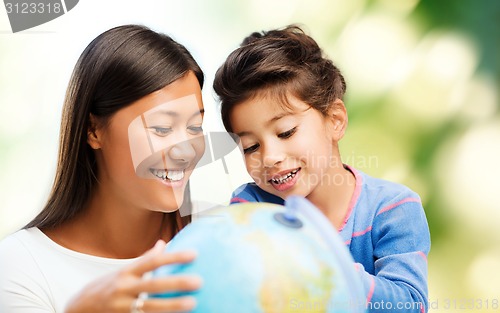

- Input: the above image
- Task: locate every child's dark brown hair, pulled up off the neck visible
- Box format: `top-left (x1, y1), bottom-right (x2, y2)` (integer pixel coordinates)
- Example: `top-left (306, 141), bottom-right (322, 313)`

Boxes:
top-left (214, 25), bottom-right (346, 132)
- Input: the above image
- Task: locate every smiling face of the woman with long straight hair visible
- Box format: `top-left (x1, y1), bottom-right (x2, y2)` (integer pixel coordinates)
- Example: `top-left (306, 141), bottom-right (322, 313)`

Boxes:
top-left (89, 72), bottom-right (205, 212)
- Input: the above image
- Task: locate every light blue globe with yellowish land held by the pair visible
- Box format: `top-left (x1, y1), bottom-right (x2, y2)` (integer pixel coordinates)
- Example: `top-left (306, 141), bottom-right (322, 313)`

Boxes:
top-left (151, 197), bottom-right (366, 313)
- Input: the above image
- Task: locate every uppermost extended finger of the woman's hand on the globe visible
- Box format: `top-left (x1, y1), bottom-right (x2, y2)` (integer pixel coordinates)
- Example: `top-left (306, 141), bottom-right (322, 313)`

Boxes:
top-left (129, 246), bottom-right (196, 276)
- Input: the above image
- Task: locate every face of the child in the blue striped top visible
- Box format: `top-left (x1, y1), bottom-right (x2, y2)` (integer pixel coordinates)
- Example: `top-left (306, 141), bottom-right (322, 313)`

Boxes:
top-left (230, 95), bottom-right (341, 199)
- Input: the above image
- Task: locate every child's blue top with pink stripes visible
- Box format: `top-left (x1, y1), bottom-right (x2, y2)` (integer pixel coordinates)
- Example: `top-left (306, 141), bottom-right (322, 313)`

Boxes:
top-left (231, 167), bottom-right (430, 312)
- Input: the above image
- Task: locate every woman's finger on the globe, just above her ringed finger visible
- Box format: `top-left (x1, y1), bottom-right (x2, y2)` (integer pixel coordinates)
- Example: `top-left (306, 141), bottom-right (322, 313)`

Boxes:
top-left (134, 275), bottom-right (203, 293)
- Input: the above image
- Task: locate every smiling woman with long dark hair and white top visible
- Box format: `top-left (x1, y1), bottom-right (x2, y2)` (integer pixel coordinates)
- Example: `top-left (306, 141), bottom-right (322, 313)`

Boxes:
top-left (0, 25), bottom-right (204, 313)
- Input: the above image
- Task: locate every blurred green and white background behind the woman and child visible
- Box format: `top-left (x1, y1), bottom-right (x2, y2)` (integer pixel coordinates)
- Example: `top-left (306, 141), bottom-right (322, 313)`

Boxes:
top-left (0, 0), bottom-right (500, 312)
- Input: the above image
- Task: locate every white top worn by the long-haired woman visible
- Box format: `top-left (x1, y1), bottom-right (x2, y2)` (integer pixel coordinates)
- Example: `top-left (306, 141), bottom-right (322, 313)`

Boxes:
top-left (0, 228), bottom-right (136, 313)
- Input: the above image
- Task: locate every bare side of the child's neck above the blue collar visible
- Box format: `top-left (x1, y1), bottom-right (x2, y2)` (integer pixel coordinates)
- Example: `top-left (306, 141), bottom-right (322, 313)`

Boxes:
top-left (307, 165), bottom-right (356, 230)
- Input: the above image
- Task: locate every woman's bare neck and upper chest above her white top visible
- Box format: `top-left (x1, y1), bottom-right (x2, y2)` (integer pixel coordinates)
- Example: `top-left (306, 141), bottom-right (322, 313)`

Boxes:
top-left (43, 193), bottom-right (174, 259)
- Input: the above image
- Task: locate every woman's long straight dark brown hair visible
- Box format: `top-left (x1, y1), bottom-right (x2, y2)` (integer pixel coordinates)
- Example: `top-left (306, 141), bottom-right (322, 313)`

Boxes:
top-left (25, 25), bottom-right (204, 230)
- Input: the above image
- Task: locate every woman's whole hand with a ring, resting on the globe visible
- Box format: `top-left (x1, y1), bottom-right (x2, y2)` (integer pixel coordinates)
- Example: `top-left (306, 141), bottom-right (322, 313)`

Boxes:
top-left (66, 240), bottom-right (201, 313)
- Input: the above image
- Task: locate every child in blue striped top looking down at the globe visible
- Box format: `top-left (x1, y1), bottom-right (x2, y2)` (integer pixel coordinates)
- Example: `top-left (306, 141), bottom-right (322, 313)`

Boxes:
top-left (214, 26), bottom-right (430, 312)
